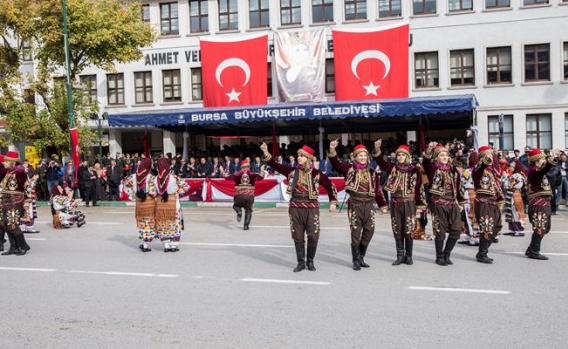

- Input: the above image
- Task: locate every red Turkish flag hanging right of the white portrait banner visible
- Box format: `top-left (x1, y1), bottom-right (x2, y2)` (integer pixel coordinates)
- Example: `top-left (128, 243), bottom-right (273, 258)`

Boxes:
top-left (333, 23), bottom-right (410, 101)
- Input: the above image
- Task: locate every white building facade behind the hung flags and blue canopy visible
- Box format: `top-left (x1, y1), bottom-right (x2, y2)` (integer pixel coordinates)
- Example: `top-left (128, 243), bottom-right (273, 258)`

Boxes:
top-left (13, 0), bottom-right (568, 154)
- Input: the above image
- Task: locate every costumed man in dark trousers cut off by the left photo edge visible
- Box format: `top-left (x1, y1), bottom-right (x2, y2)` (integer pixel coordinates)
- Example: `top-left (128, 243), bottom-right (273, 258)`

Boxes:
top-left (0, 151), bottom-right (30, 256)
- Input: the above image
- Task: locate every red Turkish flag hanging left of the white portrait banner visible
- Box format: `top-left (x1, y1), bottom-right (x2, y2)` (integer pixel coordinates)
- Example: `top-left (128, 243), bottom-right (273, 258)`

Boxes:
top-left (200, 34), bottom-right (268, 107)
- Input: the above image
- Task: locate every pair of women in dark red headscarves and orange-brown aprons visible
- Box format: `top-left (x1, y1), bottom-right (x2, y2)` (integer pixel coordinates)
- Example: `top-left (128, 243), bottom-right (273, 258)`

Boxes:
top-left (123, 158), bottom-right (189, 252)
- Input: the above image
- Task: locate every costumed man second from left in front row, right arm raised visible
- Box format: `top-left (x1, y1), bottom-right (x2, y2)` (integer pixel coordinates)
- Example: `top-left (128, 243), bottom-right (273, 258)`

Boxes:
top-left (327, 140), bottom-right (387, 270)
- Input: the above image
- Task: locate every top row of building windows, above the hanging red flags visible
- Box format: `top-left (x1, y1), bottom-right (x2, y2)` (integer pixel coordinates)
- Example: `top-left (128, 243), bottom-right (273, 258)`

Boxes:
top-left (148, 0), bottom-right (568, 35)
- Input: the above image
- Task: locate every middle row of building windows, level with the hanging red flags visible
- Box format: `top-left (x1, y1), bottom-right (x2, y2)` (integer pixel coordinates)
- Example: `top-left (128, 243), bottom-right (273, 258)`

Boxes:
top-left (81, 42), bottom-right (568, 105)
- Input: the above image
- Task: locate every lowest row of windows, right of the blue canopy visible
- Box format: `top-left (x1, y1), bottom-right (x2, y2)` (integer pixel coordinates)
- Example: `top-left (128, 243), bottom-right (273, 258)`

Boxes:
top-left (487, 113), bottom-right (568, 150)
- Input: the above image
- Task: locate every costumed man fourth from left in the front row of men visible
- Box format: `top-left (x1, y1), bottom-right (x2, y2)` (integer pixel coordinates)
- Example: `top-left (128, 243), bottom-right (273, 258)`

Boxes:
top-left (423, 142), bottom-right (465, 266)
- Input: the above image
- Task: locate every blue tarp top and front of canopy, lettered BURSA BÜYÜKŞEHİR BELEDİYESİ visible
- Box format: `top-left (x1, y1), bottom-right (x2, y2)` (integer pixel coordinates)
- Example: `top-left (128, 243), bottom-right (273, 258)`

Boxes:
top-left (109, 95), bottom-right (478, 127)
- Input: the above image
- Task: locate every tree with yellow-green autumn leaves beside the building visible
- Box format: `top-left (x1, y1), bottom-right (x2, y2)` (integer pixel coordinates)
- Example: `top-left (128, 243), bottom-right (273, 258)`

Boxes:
top-left (0, 0), bottom-right (155, 152)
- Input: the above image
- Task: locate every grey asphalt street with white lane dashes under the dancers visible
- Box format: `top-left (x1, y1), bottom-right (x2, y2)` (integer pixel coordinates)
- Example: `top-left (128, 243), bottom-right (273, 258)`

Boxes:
top-left (0, 206), bottom-right (568, 349)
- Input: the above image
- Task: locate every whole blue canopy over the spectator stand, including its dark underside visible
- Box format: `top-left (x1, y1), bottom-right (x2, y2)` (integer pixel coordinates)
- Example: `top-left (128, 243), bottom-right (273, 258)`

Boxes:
top-left (109, 95), bottom-right (478, 136)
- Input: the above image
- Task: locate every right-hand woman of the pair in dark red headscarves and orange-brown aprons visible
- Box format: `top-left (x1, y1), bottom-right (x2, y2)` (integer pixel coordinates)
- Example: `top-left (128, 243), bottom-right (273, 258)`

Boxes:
top-left (147, 158), bottom-right (189, 252)
